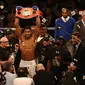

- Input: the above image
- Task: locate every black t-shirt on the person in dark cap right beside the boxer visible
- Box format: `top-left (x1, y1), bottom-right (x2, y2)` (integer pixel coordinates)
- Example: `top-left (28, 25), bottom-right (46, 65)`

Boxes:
top-left (36, 43), bottom-right (53, 67)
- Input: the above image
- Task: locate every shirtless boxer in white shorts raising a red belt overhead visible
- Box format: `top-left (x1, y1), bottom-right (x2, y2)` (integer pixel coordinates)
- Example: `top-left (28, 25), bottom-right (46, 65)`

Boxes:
top-left (15, 17), bottom-right (40, 76)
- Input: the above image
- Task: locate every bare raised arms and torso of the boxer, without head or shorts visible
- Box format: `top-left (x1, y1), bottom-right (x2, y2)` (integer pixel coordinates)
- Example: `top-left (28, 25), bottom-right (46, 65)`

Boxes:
top-left (15, 17), bottom-right (40, 61)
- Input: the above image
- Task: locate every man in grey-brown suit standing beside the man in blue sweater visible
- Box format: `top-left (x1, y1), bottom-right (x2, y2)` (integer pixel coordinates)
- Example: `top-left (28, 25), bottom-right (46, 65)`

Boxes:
top-left (74, 10), bottom-right (85, 42)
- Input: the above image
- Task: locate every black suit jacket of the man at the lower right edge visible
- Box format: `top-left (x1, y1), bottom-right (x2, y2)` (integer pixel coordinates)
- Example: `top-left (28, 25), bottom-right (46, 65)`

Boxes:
top-left (74, 43), bottom-right (85, 85)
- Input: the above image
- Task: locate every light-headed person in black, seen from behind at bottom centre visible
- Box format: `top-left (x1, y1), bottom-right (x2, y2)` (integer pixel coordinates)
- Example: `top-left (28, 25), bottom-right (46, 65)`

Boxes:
top-left (34, 64), bottom-right (53, 85)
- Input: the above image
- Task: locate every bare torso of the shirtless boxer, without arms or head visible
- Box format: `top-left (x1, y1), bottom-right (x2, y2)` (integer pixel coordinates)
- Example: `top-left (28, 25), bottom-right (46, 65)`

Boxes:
top-left (20, 35), bottom-right (36, 61)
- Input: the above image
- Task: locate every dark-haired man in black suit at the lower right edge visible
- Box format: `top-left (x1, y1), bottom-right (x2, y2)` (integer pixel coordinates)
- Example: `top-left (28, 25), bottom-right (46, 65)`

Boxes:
top-left (69, 32), bottom-right (85, 85)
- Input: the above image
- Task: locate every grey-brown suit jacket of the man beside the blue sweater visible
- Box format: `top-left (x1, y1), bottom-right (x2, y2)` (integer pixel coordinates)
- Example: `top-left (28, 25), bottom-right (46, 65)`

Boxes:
top-left (74, 20), bottom-right (85, 42)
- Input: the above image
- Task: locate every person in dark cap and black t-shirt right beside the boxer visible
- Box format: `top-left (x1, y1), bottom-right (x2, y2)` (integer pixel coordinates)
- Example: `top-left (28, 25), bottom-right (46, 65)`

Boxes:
top-left (36, 38), bottom-right (53, 71)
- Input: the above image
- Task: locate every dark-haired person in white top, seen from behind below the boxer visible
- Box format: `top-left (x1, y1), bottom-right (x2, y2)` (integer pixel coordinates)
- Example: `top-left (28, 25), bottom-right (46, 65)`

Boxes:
top-left (13, 68), bottom-right (34, 85)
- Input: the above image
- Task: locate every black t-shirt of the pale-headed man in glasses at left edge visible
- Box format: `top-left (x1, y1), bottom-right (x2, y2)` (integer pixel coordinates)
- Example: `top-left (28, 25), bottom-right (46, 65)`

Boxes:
top-left (0, 47), bottom-right (9, 61)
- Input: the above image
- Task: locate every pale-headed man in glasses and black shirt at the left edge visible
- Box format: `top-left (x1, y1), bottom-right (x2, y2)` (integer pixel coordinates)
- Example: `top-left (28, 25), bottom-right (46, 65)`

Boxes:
top-left (0, 36), bottom-right (13, 64)
